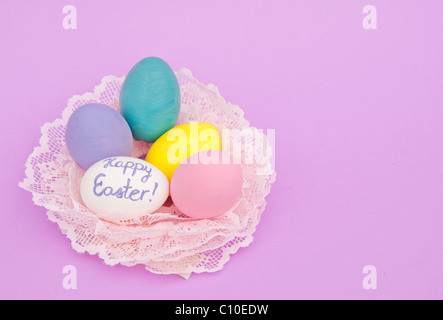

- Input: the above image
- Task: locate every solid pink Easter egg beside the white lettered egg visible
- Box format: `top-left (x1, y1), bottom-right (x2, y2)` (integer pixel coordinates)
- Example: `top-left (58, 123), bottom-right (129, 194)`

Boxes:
top-left (171, 150), bottom-right (243, 219)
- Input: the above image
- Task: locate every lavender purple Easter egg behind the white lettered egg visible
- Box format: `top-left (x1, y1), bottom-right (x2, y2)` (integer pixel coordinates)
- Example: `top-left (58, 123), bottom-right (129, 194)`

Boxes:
top-left (65, 103), bottom-right (134, 170)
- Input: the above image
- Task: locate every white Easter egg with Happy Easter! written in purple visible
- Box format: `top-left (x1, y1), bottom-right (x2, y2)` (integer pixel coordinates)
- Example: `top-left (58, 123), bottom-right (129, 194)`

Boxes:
top-left (80, 157), bottom-right (169, 217)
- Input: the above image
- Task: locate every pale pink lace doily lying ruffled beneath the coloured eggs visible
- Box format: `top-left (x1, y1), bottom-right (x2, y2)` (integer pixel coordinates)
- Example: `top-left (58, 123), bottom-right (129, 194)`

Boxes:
top-left (19, 69), bottom-right (275, 278)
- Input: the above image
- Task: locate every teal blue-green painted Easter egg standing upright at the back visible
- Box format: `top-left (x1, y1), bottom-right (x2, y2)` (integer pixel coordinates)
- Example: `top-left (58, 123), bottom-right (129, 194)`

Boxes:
top-left (120, 57), bottom-right (180, 142)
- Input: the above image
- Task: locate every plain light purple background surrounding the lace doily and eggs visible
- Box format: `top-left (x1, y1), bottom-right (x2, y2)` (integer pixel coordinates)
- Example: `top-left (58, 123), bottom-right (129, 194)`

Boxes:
top-left (0, 0), bottom-right (443, 299)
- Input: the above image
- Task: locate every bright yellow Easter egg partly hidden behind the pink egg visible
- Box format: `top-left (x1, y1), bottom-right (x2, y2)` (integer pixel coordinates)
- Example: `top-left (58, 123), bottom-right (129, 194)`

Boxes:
top-left (146, 122), bottom-right (221, 181)
